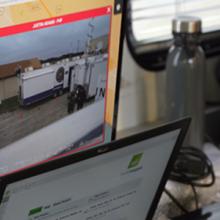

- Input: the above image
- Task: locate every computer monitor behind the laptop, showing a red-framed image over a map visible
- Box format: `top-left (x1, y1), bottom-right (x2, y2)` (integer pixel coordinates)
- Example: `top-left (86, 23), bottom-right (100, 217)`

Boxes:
top-left (0, 0), bottom-right (124, 174)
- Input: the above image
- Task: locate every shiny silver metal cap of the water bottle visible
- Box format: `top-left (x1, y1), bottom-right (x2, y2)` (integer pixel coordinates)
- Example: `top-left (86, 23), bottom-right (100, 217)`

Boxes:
top-left (172, 16), bottom-right (202, 34)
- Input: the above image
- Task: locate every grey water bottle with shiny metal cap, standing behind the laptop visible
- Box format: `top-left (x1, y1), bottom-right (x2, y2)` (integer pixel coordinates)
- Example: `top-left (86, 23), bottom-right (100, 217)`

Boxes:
top-left (166, 17), bottom-right (205, 148)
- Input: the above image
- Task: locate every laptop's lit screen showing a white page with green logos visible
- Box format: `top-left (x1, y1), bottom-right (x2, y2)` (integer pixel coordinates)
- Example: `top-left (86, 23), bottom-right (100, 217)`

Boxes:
top-left (0, 129), bottom-right (180, 220)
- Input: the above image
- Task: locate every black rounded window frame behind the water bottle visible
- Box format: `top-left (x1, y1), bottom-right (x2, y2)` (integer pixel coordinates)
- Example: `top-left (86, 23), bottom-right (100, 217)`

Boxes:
top-left (126, 4), bottom-right (220, 71)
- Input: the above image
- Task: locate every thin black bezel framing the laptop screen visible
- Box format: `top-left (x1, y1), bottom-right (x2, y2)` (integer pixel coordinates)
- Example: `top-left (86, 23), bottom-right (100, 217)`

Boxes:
top-left (0, 118), bottom-right (190, 220)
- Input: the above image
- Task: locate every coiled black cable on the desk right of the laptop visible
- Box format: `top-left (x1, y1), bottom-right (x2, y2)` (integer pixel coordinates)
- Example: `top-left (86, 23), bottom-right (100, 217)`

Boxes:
top-left (165, 146), bottom-right (215, 213)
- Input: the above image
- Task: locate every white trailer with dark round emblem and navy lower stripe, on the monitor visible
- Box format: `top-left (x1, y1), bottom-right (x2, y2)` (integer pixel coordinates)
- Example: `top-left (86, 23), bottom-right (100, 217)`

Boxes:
top-left (18, 62), bottom-right (72, 106)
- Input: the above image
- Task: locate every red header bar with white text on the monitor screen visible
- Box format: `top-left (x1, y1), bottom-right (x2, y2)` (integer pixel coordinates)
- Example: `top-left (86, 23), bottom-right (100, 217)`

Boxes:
top-left (0, 6), bottom-right (112, 37)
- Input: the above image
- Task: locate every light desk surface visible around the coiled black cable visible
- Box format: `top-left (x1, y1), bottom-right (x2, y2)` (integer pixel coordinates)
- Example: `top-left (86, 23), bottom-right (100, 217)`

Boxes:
top-left (154, 144), bottom-right (220, 220)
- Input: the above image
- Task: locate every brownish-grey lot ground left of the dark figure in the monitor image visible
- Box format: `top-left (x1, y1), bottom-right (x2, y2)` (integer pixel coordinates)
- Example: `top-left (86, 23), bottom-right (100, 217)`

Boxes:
top-left (0, 94), bottom-right (68, 148)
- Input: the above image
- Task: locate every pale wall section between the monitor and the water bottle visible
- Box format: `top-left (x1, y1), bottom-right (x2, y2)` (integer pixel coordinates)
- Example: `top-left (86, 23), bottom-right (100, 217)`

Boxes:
top-left (118, 43), bottom-right (165, 131)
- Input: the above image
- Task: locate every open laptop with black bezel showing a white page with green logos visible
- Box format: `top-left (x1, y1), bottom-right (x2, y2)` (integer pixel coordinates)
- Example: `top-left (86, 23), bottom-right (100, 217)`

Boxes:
top-left (0, 119), bottom-right (190, 220)
